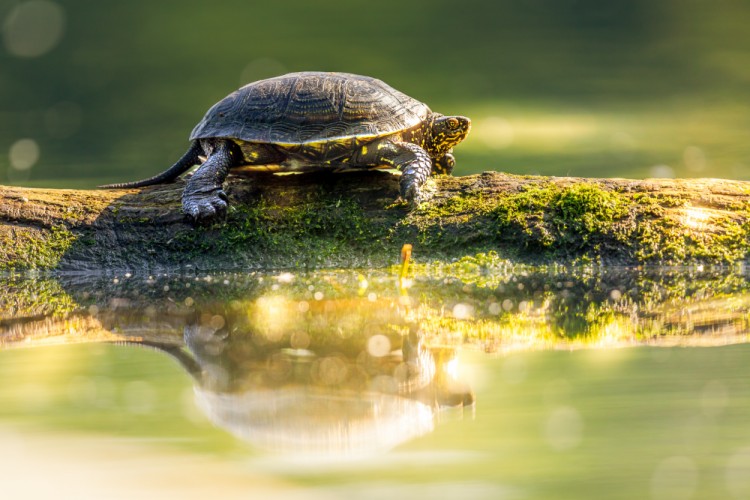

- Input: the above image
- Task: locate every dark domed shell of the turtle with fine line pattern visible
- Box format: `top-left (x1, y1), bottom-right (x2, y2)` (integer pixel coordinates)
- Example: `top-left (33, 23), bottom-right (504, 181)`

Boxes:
top-left (190, 72), bottom-right (431, 146)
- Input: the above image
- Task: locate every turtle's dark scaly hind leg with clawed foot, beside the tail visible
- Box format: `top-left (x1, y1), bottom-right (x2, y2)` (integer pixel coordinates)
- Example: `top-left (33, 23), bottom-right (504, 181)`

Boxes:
top-left (182, 141), bottom-right (235, 223)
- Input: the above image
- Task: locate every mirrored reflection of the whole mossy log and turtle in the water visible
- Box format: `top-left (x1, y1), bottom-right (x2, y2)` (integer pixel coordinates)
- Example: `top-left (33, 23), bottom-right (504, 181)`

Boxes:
top-left (0, 260), bottom-right (750, 455)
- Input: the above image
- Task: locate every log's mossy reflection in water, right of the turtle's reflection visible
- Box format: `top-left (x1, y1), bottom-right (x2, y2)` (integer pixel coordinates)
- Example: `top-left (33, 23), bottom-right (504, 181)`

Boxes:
top-left (414, 259), bottom-right (750, 352)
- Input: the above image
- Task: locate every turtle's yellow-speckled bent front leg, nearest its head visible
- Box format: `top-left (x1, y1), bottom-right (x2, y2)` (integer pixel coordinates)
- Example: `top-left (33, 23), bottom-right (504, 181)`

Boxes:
top-left (353, 141), bottom-right (432, 208)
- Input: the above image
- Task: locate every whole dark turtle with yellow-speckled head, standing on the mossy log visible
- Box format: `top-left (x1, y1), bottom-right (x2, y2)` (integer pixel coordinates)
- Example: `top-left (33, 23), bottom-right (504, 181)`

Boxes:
top-left (101, 71), bottom-right (471, 223)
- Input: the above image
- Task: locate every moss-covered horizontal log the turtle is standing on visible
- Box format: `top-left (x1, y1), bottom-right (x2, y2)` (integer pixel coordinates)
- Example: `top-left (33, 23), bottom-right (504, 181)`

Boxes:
top-left (0, 172), bottom-right (750, 271)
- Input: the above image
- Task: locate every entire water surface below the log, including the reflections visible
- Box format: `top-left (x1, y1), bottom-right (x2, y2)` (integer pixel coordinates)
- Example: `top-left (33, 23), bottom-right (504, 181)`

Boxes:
top-left (0, 262), bottom-right (750, 499)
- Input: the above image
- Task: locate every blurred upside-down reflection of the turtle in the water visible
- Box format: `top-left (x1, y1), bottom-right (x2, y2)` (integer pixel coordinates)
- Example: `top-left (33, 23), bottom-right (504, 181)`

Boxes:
top-left (161, 296), bottom-right (473, 455)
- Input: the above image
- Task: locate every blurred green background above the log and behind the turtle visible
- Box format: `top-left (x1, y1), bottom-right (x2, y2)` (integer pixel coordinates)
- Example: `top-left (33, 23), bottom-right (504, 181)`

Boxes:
top-left (0, 0), bottom-right (750, 187)
